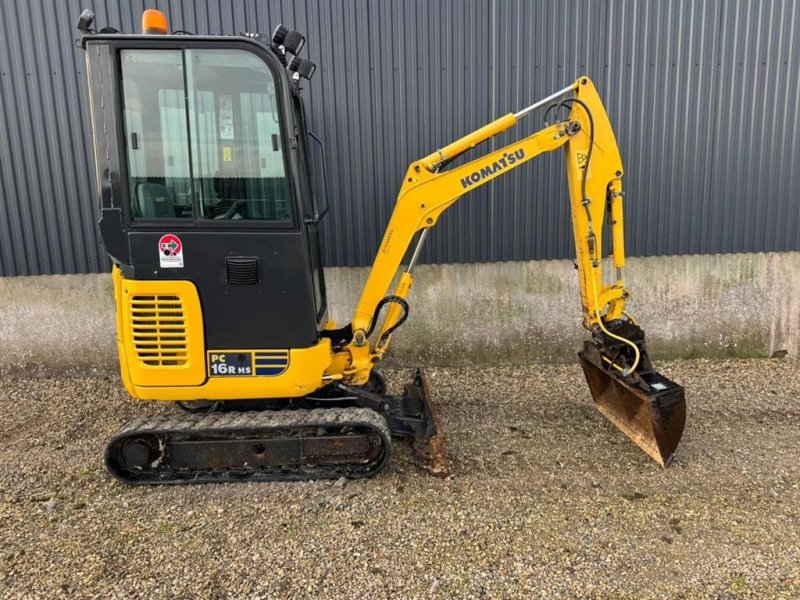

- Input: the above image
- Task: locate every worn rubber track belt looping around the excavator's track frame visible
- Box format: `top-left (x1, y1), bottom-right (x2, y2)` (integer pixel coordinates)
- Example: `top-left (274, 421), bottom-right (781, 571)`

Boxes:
top-left (106, 408), bottom-right (391, 485)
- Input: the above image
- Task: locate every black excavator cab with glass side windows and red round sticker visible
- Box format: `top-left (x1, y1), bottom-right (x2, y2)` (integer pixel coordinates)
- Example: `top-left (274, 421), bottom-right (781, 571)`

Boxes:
top-left (86, 21), bottom-right (327, 368)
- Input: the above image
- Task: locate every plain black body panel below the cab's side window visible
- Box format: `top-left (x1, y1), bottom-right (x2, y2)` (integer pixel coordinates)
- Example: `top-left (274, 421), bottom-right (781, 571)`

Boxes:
top-left (125, 230), bottom-right (318, 349)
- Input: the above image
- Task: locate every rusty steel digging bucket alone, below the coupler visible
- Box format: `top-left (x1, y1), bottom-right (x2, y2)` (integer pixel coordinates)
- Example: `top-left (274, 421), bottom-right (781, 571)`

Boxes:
top-left (578, 341), bottom-right (686, 467)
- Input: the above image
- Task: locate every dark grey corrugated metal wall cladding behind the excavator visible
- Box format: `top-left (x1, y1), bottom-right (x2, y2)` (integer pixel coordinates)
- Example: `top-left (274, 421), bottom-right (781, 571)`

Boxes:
top-left (0, 0), bottom-right (800, 275)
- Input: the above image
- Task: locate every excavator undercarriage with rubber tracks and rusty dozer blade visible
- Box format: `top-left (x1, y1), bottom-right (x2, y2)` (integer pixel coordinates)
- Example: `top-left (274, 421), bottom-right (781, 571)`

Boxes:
top-left (106, 370), bottom-right (448, 484)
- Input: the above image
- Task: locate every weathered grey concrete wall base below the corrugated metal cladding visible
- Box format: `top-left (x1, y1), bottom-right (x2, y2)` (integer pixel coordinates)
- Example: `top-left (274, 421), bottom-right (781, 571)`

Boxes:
top-left (0, 252), bottom-right (800, 375)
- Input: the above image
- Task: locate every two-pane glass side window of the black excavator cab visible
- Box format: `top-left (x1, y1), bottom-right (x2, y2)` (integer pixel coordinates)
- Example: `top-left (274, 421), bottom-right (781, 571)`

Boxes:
top-left (120, 49), bottom-right (292, 223)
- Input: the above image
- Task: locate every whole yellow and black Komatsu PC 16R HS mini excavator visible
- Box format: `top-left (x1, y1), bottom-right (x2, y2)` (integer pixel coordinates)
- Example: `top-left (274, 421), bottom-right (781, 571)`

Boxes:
top-left (78, 10), bottom-right (686, 484)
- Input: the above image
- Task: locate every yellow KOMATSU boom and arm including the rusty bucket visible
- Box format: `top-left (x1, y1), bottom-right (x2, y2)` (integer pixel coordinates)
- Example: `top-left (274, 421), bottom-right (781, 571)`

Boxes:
top-left (328, 77), bottom-right (685, 465)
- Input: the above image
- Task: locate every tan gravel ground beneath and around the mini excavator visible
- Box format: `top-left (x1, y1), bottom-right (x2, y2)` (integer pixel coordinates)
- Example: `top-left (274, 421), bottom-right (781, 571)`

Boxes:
top-left (0, 359), bottom-right (800, 598)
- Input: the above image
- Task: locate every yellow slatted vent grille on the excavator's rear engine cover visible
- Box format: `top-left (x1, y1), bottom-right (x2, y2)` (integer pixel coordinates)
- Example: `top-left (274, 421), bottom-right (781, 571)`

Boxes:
top-left (130, 294), bottom-right (189, 367)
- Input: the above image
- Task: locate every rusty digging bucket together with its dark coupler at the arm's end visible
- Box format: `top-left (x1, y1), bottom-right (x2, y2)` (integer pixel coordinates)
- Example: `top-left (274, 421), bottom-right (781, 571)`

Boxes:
top-left (578, 320), bottom-right (686, 467)
